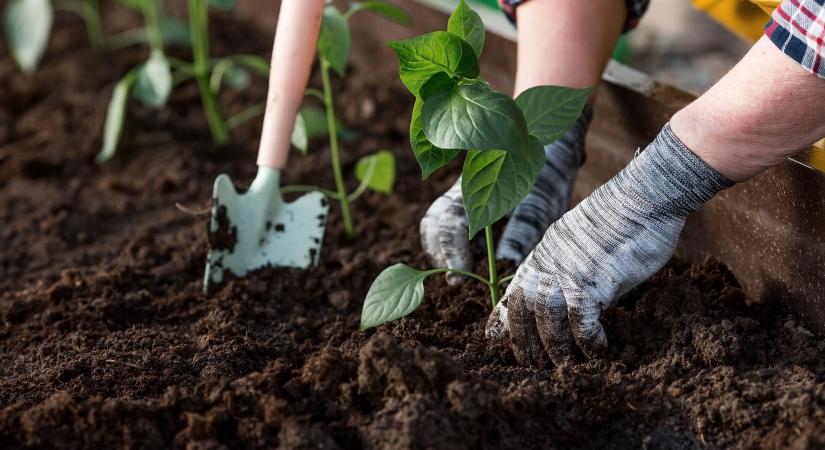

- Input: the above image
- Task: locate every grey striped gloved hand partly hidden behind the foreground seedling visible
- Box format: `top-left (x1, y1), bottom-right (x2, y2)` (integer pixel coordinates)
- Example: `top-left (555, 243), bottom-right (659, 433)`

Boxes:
top-left (419, 104), bottom-right (593, 285)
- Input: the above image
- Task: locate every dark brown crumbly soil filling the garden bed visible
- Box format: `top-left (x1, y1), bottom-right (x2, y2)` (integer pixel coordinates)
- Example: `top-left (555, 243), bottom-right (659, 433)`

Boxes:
top-left (0, 7), bottom-right (825, 449)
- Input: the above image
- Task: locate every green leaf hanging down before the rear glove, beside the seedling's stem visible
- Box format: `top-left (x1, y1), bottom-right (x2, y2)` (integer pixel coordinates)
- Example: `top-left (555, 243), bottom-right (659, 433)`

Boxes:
top-left (461, 137), bottom-right (544, 238)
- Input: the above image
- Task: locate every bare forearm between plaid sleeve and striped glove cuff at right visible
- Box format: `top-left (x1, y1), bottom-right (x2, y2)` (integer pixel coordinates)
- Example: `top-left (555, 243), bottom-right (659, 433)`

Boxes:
top-left (671, 37), bottom-right (825, 181)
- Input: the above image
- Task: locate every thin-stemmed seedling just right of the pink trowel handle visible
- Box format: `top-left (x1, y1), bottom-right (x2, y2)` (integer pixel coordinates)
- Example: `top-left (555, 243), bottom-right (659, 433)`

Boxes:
top-left (282, 1), bottom-right (412, 238)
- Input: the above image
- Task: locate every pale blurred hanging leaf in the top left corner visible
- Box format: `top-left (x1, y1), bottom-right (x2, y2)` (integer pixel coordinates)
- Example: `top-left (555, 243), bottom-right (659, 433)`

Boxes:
top-left (3, 0), bottom-right (54, 74)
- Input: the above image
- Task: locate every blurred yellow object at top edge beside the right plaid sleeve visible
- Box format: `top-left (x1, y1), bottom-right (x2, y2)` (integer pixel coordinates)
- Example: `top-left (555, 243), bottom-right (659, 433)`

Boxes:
top-left (693, 0), bottom-right (768, 42)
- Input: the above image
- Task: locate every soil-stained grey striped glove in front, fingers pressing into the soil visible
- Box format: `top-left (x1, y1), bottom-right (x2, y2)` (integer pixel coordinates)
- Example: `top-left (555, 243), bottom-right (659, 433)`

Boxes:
top-left (486, 124), bottom-right (733, 367)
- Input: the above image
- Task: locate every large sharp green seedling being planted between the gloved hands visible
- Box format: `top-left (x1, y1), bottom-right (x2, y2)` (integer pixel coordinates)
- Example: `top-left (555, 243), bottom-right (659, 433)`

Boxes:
top-left (361, 0), bottom-right (591, 330)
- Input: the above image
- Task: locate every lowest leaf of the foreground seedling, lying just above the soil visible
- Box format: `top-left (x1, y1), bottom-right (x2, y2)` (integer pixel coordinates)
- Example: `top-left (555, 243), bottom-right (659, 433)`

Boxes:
top-left (360, 264), bottom-right (435, 331)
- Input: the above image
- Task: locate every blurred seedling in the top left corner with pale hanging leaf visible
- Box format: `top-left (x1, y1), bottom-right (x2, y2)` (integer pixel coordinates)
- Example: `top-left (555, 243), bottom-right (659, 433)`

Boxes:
top-left (3, 0), bottom-right (104, 74)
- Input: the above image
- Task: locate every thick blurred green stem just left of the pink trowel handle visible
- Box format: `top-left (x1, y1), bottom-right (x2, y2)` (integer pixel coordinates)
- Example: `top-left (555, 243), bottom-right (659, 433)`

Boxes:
top-left (189, 0), bottom-right (229, 144)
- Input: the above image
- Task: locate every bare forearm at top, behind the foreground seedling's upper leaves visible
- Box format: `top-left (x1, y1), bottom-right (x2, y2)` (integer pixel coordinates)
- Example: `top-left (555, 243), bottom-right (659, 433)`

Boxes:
top-left (515, 0), bottom-right (627, 95)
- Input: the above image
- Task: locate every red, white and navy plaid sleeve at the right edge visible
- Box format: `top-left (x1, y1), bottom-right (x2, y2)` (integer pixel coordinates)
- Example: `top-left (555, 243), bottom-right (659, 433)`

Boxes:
top-left (765, 0), bottom-right (825, 78)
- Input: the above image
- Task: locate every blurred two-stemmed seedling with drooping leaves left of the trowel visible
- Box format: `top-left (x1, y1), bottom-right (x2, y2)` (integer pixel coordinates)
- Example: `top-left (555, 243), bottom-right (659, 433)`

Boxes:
top-left (97, 0), bottom-right (269, 163)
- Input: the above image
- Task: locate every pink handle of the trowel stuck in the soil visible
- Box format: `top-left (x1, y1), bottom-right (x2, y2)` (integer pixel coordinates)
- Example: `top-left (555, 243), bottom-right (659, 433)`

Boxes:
top-left (258, 0), bottom-right (324, 170)
